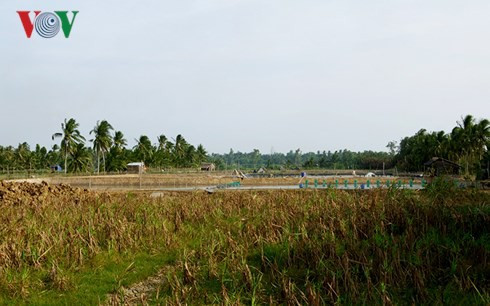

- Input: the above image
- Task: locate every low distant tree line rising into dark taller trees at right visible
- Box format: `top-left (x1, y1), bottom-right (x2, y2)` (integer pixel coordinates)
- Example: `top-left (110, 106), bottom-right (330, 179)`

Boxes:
top-left (210, 115), bottom-right (490, 178)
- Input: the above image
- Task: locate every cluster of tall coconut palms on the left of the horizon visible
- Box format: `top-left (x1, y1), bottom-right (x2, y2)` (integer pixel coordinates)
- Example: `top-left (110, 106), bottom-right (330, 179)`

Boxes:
top-left (0, 118), bottom-right (207, 173)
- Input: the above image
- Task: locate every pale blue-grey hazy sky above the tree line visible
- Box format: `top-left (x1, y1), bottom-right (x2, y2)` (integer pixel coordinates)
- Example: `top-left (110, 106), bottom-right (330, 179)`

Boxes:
top-left (0, 0), bottom-right (490, 153)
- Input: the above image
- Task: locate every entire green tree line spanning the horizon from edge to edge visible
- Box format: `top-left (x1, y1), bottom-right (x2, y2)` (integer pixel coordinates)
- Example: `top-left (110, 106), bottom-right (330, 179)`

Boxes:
top-left (0, 115), bottom-right (490, 177)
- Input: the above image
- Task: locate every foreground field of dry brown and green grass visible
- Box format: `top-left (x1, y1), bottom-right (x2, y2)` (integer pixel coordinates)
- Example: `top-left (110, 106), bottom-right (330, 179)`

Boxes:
top-left (0, 182), bottom-right (490, 305)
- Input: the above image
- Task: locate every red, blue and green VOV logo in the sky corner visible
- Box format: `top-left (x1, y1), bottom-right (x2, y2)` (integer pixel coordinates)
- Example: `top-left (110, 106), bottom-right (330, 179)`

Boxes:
top-left (17, 11), bottom-right (78, 38)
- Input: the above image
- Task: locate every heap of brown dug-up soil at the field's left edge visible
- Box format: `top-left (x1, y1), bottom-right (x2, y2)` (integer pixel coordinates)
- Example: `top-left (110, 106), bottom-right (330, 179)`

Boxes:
top-left (0, 181), bottom-right (91, 206)
